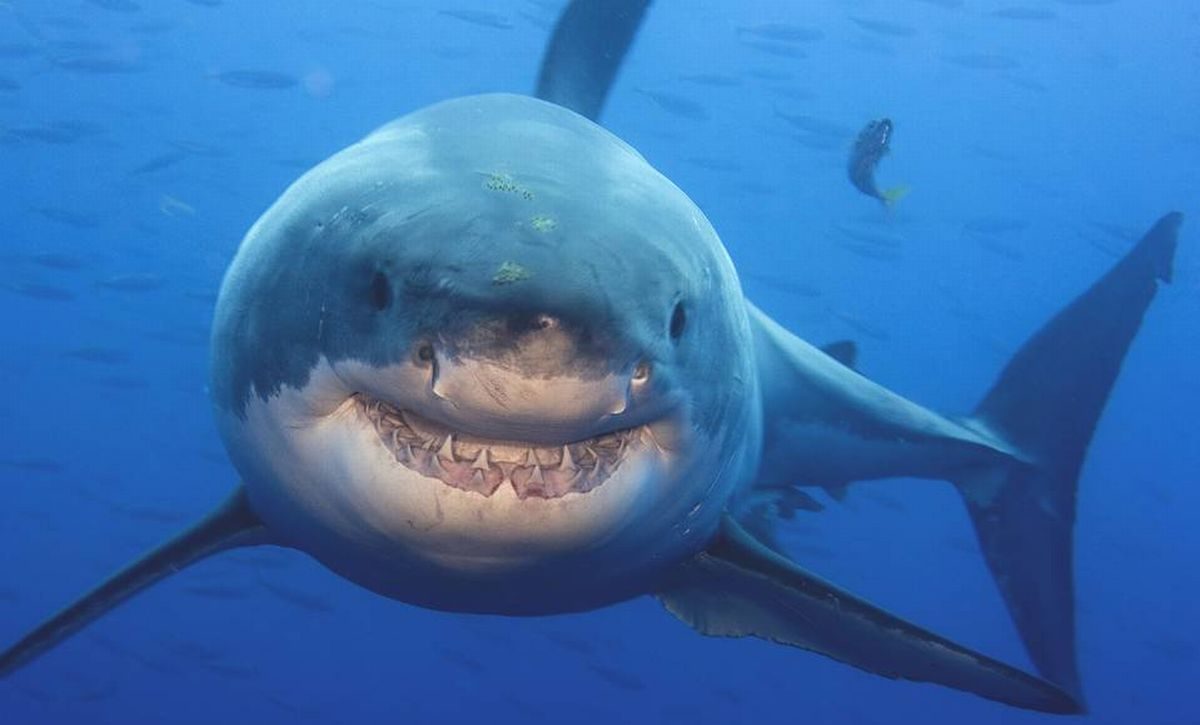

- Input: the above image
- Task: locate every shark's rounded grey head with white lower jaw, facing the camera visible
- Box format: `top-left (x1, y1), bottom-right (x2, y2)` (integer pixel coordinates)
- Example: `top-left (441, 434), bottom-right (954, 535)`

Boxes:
top-left (212, 95), bottom-right (758, 613)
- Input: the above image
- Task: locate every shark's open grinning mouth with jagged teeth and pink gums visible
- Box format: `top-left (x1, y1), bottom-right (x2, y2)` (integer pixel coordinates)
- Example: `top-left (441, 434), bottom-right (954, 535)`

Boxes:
top-left (354, 394), bottom-right (653, 501)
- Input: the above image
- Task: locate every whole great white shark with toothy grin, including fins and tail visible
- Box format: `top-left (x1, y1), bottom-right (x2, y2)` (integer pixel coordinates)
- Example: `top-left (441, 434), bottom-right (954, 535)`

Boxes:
top-left (0, 0), bottom-right (1181, 713)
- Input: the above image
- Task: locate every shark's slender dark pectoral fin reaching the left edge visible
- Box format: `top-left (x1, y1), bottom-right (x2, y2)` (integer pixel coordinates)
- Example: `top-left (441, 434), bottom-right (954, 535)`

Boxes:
top-left (0, 486), bottom-right (270, 677)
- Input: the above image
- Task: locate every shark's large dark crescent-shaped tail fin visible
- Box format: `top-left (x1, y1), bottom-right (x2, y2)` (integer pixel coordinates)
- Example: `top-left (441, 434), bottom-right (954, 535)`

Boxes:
top-left (956, 212), bottom-right (1183, 695)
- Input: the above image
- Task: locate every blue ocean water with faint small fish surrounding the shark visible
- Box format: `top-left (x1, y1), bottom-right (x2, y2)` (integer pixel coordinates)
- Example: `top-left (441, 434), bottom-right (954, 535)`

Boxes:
top-left (0, 0), bottom-right (1200, 724)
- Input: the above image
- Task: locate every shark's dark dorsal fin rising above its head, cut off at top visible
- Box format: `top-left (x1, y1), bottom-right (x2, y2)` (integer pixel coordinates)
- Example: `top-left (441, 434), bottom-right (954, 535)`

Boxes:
top-left (534, 0), bottom-right (650, 121)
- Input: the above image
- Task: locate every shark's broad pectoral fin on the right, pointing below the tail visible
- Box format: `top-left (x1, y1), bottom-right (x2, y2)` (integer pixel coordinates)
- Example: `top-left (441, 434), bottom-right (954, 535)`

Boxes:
top-left (659, 517), bottom-right (1082, 714)
